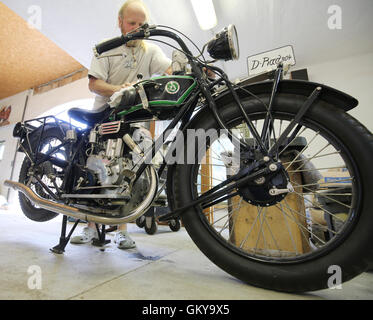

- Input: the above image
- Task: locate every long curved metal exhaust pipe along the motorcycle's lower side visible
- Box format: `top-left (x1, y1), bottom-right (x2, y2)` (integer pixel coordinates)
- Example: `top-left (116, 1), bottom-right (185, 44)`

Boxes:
top-left (4, 166), bottom-right (158, 225)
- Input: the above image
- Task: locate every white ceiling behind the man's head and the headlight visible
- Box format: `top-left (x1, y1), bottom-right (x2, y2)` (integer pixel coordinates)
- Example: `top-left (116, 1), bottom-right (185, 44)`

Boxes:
top-left (2, 0), bottom-right (373, 77)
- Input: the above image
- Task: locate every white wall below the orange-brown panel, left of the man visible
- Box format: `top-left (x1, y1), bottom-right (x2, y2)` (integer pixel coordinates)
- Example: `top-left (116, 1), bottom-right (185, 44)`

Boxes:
top-left (0, 78), bottom-right (94, 201)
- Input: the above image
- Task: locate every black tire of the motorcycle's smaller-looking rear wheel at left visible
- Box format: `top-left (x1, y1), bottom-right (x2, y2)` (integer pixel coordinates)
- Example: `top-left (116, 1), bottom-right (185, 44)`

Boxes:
top-left (18, 126), bottom-right (64, 222)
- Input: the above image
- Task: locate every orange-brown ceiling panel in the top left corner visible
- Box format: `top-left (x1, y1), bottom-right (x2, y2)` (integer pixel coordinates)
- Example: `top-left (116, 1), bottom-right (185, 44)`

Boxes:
top-left (0, 2), bottom-right (83, 99)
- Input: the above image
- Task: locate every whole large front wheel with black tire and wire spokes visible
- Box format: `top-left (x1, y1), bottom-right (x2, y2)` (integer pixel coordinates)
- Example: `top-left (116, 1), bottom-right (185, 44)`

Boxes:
top-left (174, 95), bottom-right (373, 292)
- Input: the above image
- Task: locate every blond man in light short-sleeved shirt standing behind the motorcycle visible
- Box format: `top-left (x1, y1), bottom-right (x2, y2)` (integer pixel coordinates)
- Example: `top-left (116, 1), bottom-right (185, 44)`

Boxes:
top-left (70, 0), bottom-right (172, 249)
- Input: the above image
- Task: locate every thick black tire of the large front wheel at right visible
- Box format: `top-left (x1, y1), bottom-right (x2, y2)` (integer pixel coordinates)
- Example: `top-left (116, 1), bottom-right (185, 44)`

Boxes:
top-left (173, 94), bottom-right (373, 292)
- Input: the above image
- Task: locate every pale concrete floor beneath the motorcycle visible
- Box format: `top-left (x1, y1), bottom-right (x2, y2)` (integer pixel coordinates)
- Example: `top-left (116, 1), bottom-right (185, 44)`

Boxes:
top-left (0, 205), bottom-right (373, 300)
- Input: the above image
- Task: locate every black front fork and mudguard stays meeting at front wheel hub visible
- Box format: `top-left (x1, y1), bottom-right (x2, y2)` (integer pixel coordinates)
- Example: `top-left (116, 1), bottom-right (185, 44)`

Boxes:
top-left (160, 65), bottom-right (322, 221)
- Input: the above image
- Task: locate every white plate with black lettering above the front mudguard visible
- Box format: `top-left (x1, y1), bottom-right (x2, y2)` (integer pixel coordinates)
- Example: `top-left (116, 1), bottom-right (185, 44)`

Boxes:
top-left (247, 45), bottom-right (295, 76)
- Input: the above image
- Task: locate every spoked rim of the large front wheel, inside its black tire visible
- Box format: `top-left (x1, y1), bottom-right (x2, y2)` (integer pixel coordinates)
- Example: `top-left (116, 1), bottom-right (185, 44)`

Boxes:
top-left (191, 112), bottom-right (361, 263)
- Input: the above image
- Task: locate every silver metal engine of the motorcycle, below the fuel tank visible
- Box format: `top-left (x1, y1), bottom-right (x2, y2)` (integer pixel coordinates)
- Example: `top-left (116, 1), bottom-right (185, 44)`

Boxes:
top-left (86, 121), bottom-right (152, 210)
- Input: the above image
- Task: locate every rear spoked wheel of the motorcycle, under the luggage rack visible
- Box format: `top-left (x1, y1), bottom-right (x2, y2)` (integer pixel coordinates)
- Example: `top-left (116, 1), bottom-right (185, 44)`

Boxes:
top-left (19, 128), bottom-right (67, 222)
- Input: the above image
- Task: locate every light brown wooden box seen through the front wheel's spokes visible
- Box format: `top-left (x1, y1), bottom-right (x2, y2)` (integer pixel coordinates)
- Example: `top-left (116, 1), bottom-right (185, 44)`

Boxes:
top-left (229, 159), bottom-right (310, 256)
